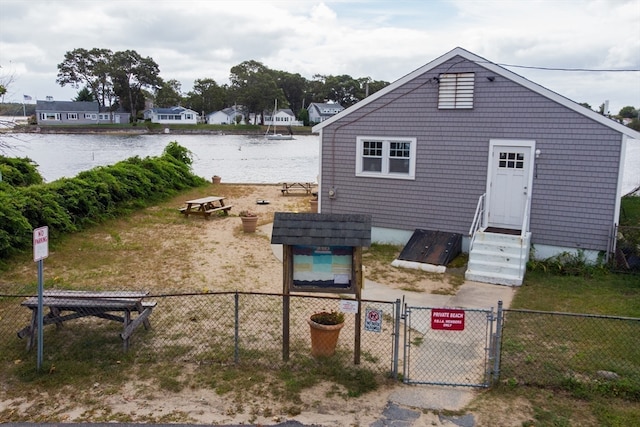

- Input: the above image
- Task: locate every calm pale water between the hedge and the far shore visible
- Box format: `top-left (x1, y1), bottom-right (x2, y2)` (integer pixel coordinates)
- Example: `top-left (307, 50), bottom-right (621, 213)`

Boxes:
top-left (5, 130), bottom-right (640, 194)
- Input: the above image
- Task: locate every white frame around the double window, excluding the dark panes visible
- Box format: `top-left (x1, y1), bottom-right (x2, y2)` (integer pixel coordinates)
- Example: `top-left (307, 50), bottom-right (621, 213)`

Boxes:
top-left (356, 136), bottom-right (418, 180)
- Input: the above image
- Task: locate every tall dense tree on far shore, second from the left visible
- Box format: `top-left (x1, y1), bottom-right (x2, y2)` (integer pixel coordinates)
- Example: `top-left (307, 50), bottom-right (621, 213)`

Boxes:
top-left (110, 50), bottom-right (162, 120)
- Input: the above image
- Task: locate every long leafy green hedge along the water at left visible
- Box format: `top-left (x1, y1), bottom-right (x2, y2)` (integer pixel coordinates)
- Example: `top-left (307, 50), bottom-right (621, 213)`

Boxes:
top-left (0, 141), bottom-right (206, 263)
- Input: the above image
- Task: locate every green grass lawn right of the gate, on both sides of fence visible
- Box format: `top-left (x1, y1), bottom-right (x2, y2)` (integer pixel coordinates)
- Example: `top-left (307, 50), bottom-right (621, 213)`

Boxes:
top-left (471, 197), bottom-right (640, 427)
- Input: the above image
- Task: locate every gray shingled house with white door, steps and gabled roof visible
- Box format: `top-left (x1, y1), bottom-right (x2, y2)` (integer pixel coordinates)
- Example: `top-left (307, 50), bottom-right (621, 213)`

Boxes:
top-left (313, 48), bottom-right (640, 285)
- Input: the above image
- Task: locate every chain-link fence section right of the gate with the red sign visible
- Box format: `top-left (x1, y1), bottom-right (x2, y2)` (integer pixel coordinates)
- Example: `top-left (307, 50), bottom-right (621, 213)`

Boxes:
top-left (500, 309), bottom-right (640, 400)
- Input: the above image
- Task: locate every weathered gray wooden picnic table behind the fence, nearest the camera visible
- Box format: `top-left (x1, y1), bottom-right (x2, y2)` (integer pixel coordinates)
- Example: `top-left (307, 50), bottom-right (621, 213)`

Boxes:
top-left (18, 290), bottom-right (156, 351)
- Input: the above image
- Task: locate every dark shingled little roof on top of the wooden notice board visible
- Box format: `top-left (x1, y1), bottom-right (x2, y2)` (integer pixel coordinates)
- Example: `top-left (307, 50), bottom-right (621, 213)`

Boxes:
top-left (271, 212), bottom-right (371, 247)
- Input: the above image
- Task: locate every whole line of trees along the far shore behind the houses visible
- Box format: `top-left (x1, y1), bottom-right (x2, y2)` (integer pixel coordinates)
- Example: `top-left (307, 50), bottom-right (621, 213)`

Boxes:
top-left (56, 48), bottom-right (389, 121)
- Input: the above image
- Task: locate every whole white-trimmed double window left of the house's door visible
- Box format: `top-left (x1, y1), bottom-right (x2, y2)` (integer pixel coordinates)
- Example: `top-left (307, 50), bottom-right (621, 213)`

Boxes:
top-left (356, 136), bottom-right (417, 179)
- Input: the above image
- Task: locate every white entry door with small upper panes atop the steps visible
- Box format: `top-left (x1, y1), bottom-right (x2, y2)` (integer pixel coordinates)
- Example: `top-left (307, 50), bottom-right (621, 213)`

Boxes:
top-left (487, 141), bottom-right (535, 230)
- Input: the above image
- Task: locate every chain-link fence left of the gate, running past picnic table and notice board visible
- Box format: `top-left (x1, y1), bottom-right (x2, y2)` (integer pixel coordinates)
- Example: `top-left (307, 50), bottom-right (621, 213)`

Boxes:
top-left (0, 292), bottom-right (401, 377)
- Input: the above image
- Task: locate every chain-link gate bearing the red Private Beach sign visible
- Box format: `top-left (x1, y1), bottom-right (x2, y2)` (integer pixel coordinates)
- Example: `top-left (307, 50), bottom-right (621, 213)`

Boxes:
top-left (403, 307), bottom-right (499, 387)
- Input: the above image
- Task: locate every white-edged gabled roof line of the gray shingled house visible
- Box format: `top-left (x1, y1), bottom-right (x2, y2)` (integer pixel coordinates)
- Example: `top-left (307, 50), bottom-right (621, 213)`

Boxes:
top-left (312, 47), bottom-right (640, 139)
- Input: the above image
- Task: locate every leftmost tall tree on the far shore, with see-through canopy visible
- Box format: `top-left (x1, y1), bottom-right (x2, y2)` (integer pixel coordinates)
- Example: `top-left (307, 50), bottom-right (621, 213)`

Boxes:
top-left (56, 48), bottom-right (113, 107)
